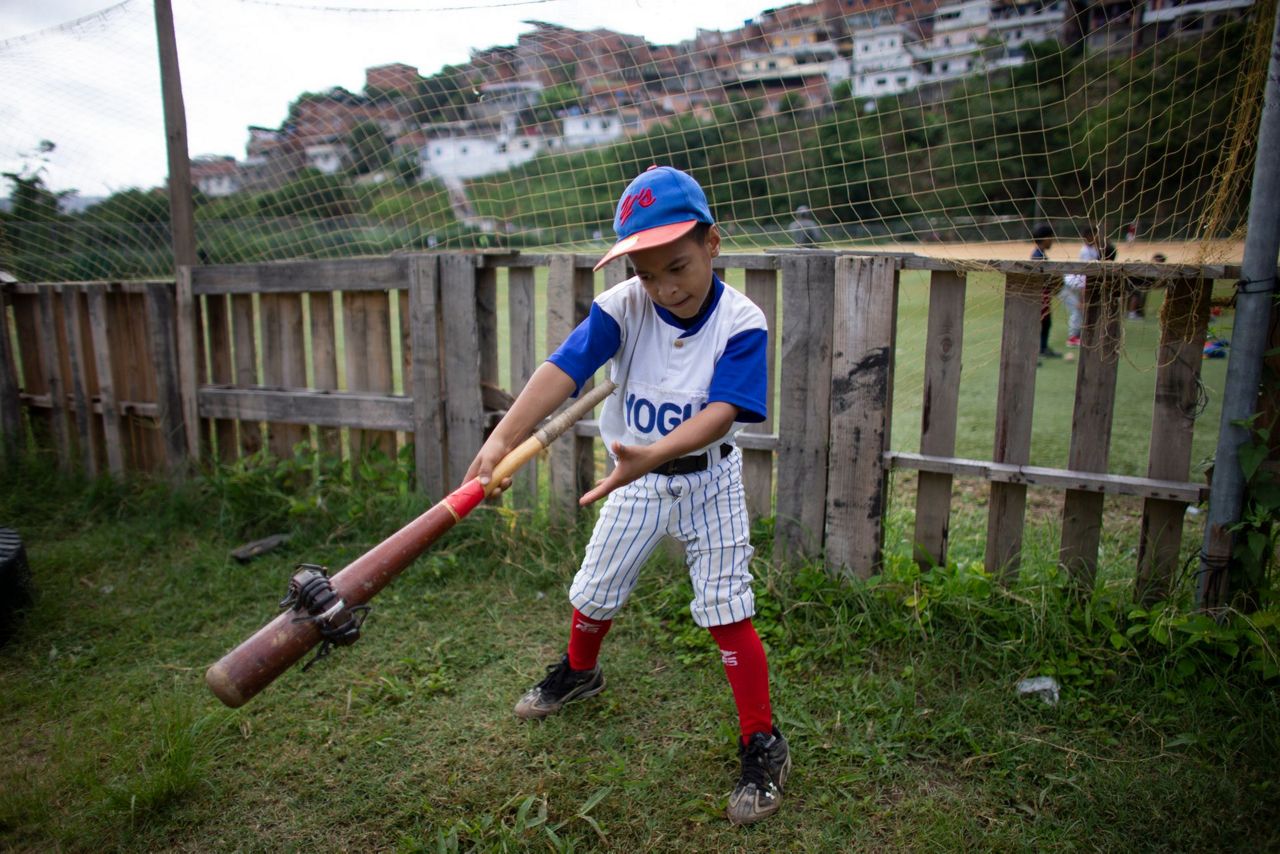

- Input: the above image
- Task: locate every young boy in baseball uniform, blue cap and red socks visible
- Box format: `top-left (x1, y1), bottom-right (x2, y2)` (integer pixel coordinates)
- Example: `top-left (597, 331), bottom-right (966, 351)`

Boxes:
top-left (467, 166), bottom-right (791, 823)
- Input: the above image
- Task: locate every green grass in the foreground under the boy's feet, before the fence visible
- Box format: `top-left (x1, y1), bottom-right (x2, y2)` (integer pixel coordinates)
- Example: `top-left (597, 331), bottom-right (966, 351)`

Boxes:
top-left (0, 463), bottom-right (1280, 851)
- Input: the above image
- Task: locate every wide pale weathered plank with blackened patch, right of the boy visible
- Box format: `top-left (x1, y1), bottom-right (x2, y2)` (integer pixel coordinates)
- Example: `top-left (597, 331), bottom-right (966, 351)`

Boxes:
top-left (826, 256), bottom-right (897, 579)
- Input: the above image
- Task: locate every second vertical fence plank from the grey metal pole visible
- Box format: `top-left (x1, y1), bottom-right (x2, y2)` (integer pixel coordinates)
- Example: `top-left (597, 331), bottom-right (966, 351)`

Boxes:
top-left (1057, 277), bottom-right (1128, 592)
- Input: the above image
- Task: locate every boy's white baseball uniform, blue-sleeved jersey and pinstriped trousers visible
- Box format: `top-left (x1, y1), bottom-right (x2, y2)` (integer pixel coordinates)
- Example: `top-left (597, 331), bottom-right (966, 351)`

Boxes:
top-left (549, 278), bottom-right (768, 626)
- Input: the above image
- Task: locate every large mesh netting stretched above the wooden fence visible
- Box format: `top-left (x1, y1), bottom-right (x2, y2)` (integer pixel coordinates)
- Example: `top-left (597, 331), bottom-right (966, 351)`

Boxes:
top-left (0, 0), bottom-right (1275, 280)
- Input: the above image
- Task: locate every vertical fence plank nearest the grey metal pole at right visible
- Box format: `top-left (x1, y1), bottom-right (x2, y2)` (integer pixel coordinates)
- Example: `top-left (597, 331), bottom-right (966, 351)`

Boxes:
top-left (1134, 279), bottom-right (1213, 604)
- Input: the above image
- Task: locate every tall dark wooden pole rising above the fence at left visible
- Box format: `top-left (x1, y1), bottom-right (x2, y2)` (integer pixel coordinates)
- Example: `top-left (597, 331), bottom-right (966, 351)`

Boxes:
top-left (155, 0), bottom-right (196, 270)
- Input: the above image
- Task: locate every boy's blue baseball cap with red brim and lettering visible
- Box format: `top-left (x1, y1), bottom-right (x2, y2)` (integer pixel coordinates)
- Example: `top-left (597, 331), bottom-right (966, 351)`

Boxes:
top-left (595, 166), bottom-right (716, 270)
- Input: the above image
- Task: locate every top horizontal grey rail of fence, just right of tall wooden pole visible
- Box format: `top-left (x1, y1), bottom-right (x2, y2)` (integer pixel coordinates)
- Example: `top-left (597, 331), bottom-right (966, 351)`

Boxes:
top-left (192, 256), bottom-right (407, 294)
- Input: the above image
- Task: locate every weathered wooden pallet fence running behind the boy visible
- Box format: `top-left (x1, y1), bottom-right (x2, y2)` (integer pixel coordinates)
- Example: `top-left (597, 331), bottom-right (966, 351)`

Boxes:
top-left (0, 251), bottom-right (1238, 600)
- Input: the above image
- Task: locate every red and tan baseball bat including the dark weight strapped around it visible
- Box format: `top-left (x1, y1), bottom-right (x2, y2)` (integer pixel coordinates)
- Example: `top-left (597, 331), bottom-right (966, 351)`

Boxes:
top-left (205, 382), bottom-right (617, 708)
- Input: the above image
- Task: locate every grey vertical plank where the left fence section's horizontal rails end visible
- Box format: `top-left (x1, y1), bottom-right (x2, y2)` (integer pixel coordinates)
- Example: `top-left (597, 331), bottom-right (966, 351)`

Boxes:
top-left (408, 255), bottom-right (449, 501)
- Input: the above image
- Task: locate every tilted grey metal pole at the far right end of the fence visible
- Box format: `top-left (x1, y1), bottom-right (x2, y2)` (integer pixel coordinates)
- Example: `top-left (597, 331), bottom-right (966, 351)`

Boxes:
top-left (1196, 5), bottom-right (1280, 608)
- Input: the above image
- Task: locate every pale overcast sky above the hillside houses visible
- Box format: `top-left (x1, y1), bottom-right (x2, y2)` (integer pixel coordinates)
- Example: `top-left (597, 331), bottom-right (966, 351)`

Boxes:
top-left (0, 0), bottom-right (773, 196)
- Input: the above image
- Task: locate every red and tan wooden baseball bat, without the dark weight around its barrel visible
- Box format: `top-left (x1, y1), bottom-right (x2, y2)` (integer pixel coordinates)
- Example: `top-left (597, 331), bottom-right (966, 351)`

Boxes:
top-left (205, 382), bottom-right (617, 708)
